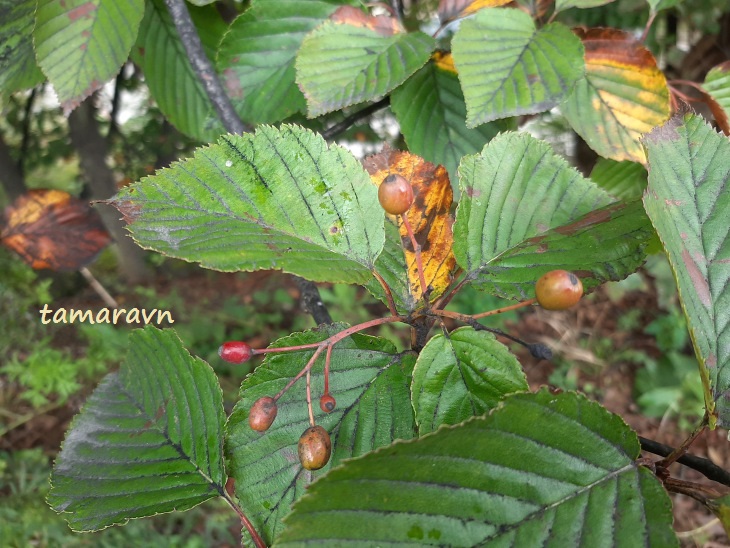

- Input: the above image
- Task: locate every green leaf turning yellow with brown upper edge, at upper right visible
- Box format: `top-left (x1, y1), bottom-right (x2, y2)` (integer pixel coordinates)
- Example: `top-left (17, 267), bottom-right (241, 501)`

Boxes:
top-left (562, 28), bottom-right (670, 163)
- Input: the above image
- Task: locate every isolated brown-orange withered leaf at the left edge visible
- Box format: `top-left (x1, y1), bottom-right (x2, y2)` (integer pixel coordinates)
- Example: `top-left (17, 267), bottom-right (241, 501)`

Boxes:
top-left (0, 190), bottom-right (111, 270)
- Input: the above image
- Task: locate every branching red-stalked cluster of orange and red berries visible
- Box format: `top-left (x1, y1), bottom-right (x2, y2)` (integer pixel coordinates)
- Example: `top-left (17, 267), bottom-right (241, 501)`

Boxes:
top-left (218, 174), bottom-right (583, 470)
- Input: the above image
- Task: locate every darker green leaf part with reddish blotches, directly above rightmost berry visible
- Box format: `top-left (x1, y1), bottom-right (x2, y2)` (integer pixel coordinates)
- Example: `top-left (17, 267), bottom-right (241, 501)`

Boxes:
top-left (473, 200), bottom-right (654, 299)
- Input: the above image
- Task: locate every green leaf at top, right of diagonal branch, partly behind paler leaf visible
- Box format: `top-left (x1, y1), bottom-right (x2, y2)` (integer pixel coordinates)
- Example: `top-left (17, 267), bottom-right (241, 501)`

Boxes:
top-left (218, 0), bottom-right (336, 123)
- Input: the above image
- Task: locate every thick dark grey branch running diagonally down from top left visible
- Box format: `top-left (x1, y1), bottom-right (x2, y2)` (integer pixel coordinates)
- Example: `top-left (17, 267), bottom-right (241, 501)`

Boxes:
top-left (165, 0), bottom-right (251, 133)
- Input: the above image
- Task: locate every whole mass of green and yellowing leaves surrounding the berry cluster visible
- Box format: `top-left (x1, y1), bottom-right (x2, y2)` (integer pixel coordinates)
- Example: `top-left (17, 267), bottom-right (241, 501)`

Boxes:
top-left (0, 0), bottom-right (730, 546)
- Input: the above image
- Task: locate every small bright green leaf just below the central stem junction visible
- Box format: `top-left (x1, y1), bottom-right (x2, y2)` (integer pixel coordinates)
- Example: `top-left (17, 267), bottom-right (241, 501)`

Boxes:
top-left (411, 327), bottom-right (529, 435)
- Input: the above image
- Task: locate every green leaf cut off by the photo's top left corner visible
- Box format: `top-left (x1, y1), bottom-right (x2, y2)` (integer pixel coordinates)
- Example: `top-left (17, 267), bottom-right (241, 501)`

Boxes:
top-left (0, 0), bottom-right (44, 93)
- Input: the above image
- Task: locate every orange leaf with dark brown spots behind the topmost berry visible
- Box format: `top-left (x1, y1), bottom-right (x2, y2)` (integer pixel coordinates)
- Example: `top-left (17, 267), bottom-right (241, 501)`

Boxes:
top-left (363, 145), bottom-right (456, 300)
